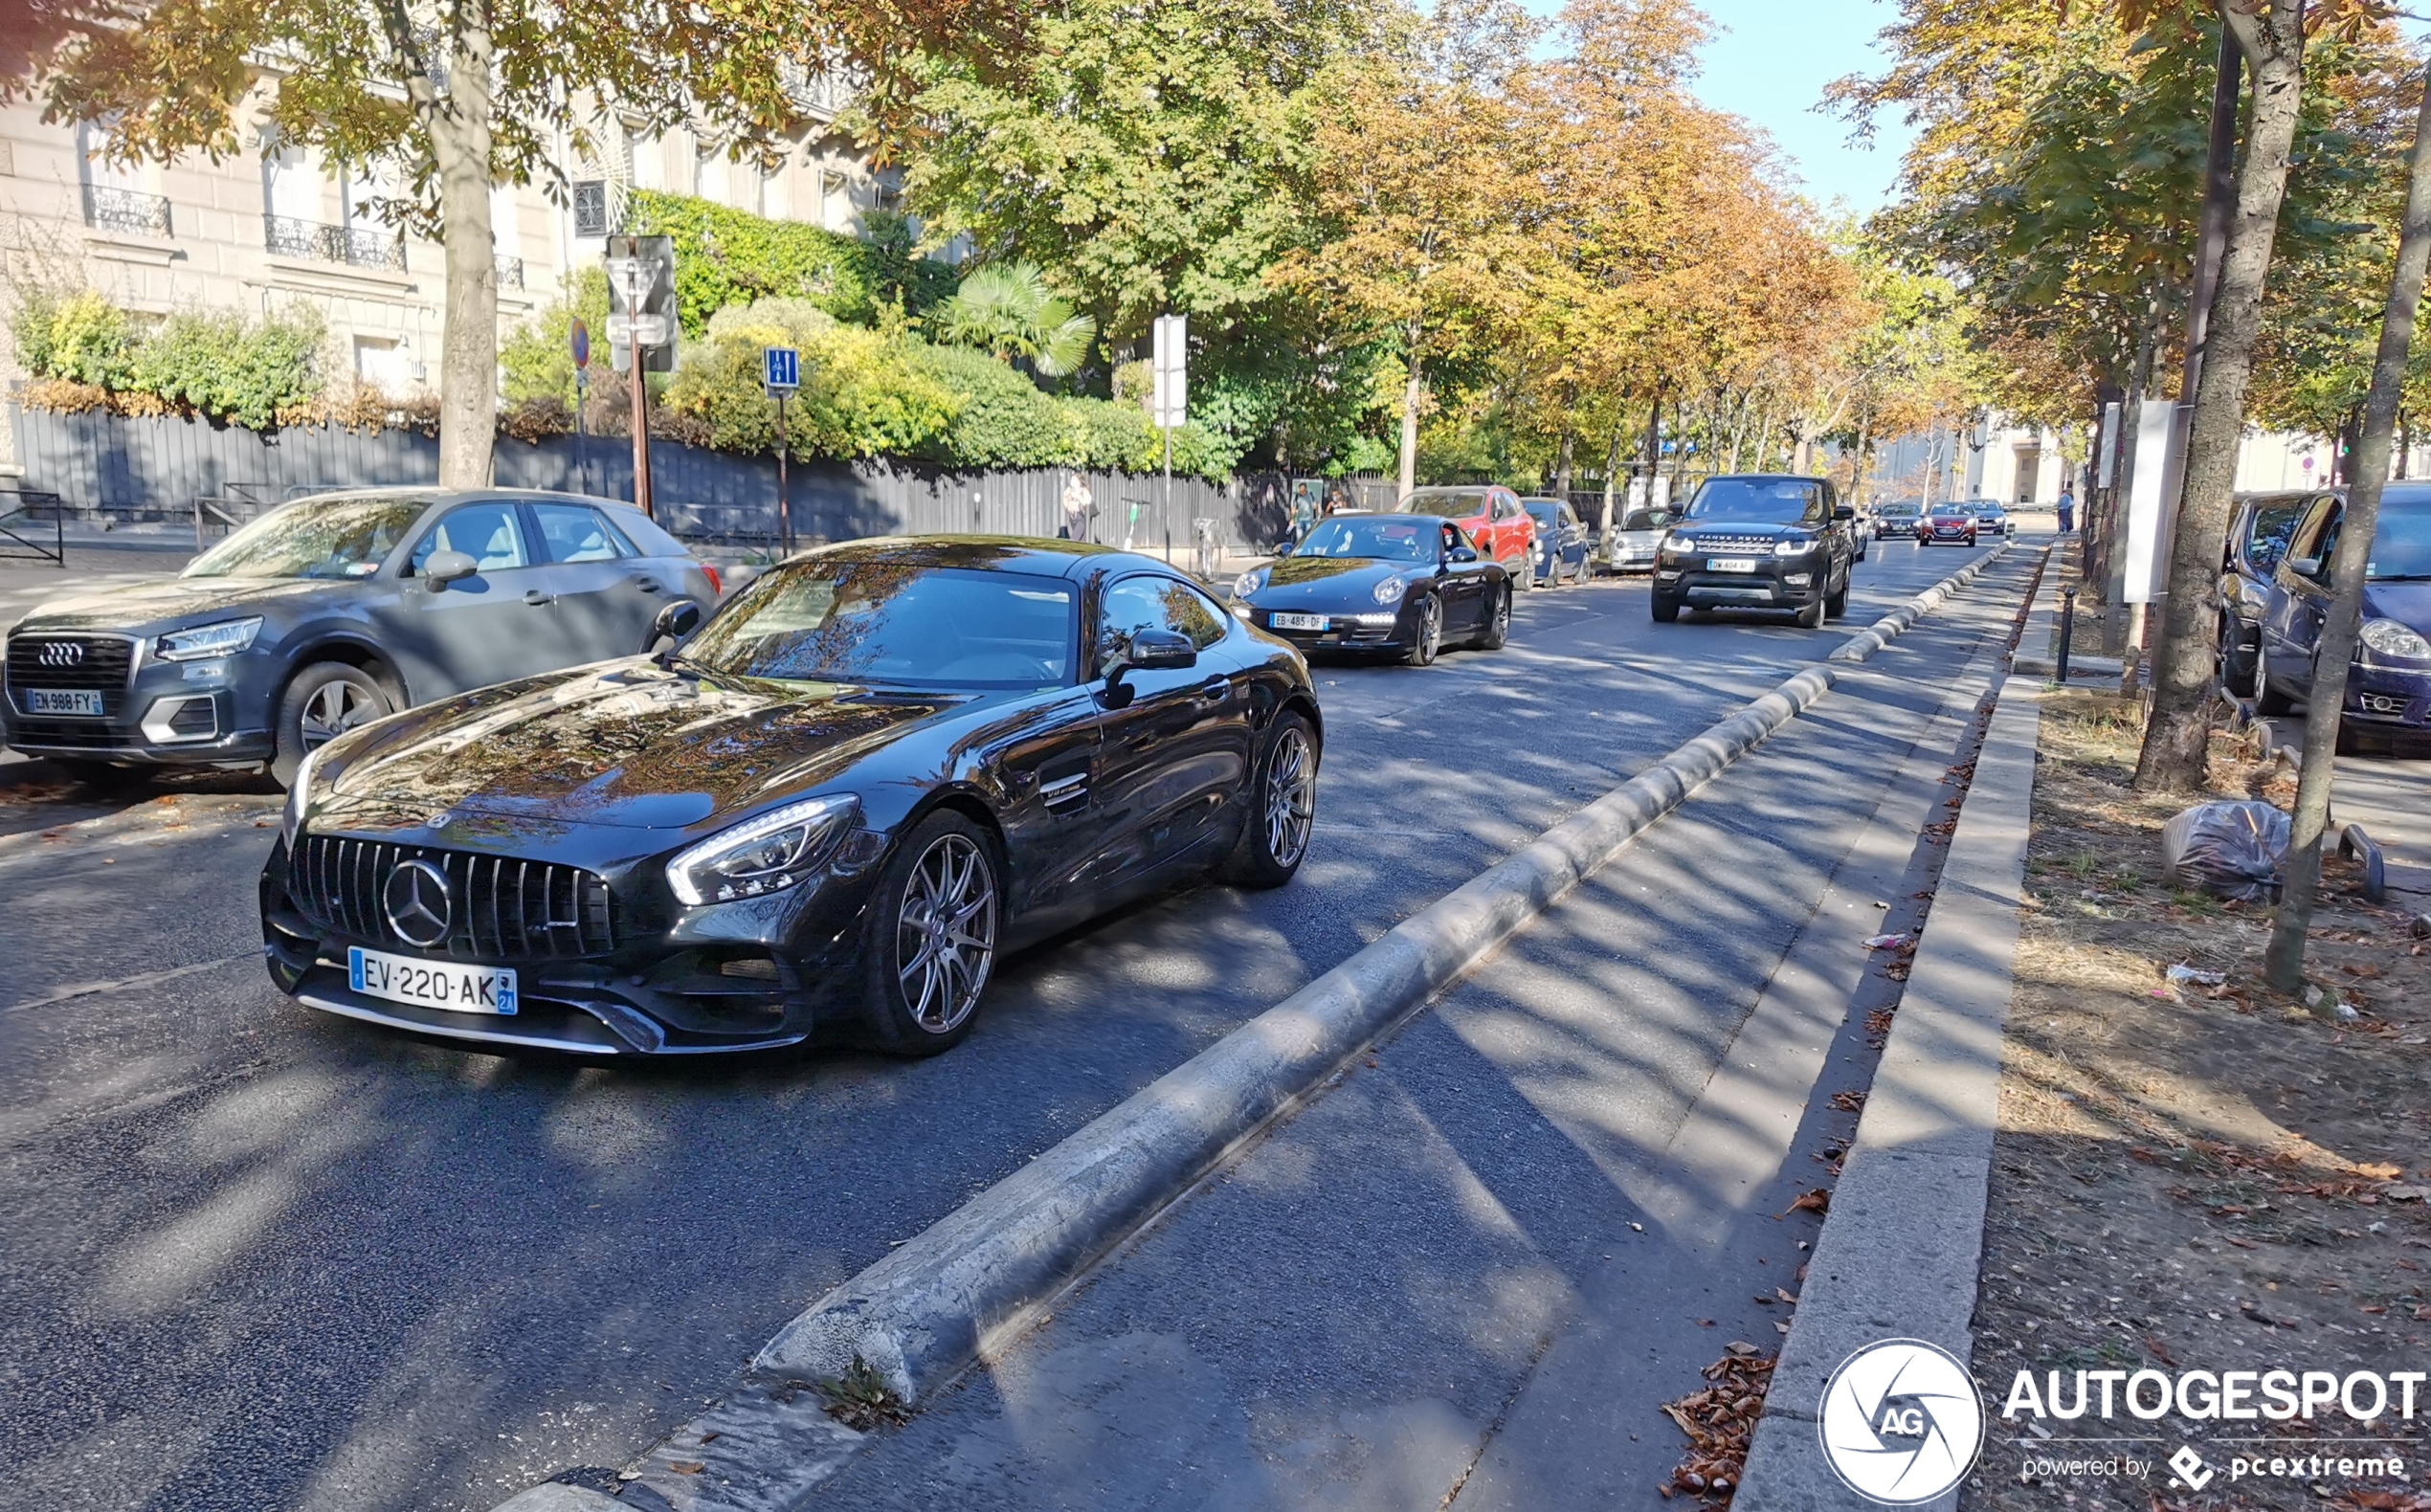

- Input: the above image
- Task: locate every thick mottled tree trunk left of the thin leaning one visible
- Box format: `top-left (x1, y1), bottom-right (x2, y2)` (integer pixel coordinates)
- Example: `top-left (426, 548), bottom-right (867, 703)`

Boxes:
top-left (2134, 0), bottom-right (2305, 792)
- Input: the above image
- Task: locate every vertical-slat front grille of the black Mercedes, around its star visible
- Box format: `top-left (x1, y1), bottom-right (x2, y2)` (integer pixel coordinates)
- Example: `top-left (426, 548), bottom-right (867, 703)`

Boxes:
top-left (287, 834), bottom-right (615, 960)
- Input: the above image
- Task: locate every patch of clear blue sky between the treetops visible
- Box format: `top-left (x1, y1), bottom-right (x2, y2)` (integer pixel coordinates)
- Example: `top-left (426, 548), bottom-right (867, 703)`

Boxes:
top-left (1697, 0), bottom-right (1908, 216)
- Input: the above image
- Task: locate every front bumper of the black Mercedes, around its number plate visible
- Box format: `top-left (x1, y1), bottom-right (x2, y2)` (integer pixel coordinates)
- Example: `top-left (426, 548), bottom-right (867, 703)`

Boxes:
top-left (260, 841), bottom-right (875, 1057)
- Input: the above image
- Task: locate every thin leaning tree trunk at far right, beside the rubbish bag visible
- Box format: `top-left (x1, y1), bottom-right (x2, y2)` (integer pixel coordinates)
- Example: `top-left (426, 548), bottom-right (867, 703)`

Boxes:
top-left (2264, 58), bottom-right (2431, 1018)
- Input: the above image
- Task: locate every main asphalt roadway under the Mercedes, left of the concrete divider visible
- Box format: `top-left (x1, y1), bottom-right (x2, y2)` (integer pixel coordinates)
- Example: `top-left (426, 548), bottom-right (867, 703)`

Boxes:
top-left (0, 545), bottom-right (1967, 1512)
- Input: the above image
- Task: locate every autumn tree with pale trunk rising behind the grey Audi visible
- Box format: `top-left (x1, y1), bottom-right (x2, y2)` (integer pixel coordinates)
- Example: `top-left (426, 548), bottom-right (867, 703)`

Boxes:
top-left (0, 0), bottom-right (1004, 486)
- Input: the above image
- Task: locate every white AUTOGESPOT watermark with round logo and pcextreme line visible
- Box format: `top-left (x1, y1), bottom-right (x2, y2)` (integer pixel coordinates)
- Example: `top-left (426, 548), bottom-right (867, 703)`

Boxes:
top-left (1816, 1340), bottom-right (2431, 1507)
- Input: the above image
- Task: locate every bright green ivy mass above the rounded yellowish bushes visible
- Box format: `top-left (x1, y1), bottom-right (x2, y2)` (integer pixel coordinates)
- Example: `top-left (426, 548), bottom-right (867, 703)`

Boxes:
top-left (627, 189), bottom-right (953, 336)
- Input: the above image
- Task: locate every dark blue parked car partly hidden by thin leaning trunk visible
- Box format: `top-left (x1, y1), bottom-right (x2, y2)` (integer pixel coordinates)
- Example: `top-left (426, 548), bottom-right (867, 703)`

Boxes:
top-left (2254, 483), bottom-right (2431, 748)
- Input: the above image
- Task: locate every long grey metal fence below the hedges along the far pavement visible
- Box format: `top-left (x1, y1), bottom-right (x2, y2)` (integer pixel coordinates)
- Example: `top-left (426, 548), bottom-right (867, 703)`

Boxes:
top-left (10, 406), bottom-right (1303, 559)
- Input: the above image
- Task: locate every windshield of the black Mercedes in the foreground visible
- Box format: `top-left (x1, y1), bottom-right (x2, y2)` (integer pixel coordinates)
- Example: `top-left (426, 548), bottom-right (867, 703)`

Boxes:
top-left (683, 562), bottom-right (1072, 688)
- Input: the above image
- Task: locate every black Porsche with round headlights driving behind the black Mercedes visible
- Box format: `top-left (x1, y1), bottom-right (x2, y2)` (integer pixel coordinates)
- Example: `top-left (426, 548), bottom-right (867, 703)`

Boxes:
top-left (1233, 516), bottom-right (1512, 666)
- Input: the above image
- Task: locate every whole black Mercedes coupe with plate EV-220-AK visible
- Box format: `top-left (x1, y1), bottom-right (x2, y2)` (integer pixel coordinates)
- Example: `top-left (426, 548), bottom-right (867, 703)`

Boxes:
top-left (260, 537), bottom-right (1323, 1055)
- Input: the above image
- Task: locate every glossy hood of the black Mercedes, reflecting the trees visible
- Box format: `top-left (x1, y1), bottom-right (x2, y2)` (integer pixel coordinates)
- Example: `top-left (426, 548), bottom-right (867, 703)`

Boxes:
top-left (314, 658), bottom-right (975, 829)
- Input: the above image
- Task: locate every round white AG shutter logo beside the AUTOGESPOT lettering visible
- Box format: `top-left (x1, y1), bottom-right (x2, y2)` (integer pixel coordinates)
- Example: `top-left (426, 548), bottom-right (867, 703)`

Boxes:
top-left (1816, 1340), bottom-right (1984, 1507)
